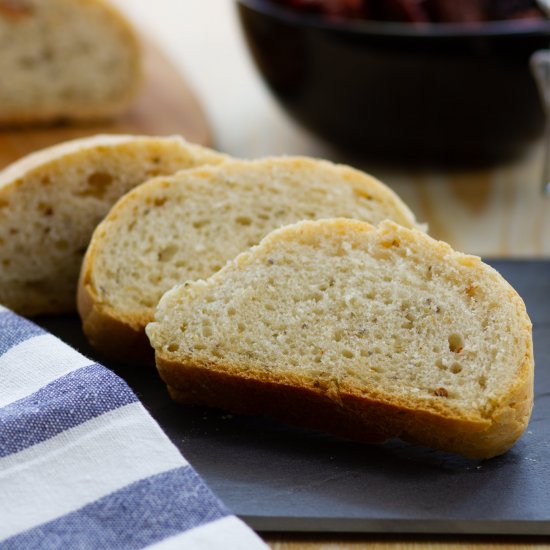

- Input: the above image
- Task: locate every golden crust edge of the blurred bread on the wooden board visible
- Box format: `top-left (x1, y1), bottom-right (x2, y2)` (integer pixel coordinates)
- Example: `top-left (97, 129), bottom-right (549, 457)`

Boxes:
top-left (0, 0), bottom-right (144, 127)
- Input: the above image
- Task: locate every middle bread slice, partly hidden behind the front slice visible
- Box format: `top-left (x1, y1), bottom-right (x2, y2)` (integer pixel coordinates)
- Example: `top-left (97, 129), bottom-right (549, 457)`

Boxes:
top-left (79, 157), bottom-right (422, 364)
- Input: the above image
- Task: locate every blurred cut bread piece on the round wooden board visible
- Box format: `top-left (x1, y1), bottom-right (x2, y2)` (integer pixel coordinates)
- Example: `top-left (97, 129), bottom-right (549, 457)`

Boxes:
top-left (0, 0), bottom-right (142, 125)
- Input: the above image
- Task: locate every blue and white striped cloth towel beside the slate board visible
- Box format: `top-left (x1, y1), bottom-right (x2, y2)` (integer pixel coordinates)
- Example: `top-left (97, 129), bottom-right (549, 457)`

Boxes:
top-left (0, 306), bottom-right (266, 550)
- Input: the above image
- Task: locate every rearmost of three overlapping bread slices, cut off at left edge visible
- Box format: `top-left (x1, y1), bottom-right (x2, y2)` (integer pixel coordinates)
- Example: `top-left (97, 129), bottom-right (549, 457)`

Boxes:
top-left (0, 136), bottom-right (224, 315)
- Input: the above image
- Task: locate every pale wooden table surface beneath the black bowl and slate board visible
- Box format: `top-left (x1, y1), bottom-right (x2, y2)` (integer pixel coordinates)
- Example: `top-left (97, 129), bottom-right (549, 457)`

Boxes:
top-left (12, 0), bottom-right (550, 550)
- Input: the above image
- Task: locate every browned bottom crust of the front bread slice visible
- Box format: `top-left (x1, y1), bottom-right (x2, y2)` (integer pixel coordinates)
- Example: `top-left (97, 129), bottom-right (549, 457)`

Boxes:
top-left (157, 354), bottom-right (532, 459)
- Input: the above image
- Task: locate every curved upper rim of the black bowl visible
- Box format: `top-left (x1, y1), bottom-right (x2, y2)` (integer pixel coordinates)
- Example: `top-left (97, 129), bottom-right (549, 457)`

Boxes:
top-left (236, 0), bottom-right (550, 37)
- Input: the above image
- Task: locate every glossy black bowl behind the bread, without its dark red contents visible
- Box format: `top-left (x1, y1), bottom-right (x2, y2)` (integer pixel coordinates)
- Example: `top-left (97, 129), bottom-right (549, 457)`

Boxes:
top-left (237, 0), bottom-right (550, 162)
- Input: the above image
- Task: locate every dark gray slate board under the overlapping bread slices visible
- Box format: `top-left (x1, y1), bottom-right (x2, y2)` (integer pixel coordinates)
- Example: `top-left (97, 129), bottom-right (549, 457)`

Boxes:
top-left (40, 260), bottom-right (550, 535)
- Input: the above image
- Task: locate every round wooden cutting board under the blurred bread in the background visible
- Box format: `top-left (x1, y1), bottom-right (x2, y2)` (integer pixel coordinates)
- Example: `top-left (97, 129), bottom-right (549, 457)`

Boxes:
top-left (0, 42), bottom-right (212, 168)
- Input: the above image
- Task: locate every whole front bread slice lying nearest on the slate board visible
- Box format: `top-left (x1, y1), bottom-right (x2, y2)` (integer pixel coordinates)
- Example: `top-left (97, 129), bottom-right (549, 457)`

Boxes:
top-left (147, 220), bottom-right (533, 458)
